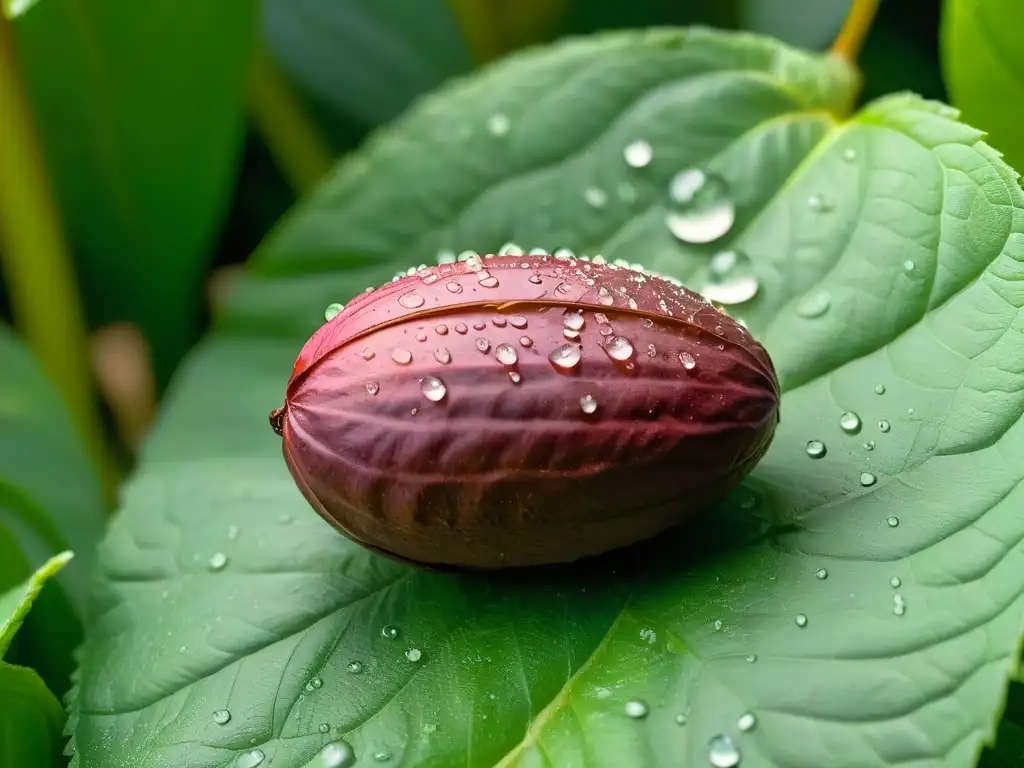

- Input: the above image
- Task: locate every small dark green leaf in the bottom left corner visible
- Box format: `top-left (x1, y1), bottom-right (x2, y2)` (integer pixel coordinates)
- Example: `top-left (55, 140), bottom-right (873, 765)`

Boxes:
top-left (0, 663), bottom-right (63, 768)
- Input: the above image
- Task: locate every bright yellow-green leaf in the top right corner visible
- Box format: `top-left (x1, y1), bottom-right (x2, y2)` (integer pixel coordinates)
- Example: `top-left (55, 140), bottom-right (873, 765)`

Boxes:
top-left (941, 0), bottom-right (1024, 182)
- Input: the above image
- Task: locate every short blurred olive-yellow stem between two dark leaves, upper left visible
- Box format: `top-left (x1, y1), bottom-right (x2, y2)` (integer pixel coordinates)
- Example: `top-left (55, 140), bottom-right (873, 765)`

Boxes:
top-left (249, 45), bottom-right (334, 196)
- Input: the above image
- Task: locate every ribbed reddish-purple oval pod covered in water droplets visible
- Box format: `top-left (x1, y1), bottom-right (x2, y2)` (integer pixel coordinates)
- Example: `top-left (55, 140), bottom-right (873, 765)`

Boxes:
top-left (271, 256), bottom-right (779, 568)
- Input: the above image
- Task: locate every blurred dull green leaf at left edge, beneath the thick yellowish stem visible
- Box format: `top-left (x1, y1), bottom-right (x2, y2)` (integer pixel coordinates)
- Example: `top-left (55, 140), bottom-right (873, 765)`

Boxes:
top-left (0, 325), bottom-right (105, 612)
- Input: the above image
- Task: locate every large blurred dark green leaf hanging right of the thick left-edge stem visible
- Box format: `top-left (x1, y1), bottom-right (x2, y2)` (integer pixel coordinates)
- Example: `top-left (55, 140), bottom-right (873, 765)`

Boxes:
top-left (14, 0), bottom-right (255, 382)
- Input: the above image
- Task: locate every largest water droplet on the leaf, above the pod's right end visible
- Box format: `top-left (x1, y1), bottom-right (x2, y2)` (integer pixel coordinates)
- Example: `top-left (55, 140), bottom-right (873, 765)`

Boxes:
top-left (665, 169), bottom-right (736, 243)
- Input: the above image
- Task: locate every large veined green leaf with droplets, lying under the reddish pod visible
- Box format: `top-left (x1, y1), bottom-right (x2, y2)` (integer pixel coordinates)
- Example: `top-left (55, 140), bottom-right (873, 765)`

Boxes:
top-left (74, 30), bottom-right (1024, 768)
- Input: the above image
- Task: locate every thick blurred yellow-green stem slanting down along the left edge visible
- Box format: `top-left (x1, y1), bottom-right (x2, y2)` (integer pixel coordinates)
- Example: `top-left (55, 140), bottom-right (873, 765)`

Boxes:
top-left (0, 12), bottom-right (117, 499)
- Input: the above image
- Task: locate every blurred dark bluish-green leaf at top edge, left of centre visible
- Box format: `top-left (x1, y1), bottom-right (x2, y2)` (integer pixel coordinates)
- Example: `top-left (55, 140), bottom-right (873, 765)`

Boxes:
top-left (263, 0), bottom-right (471, 126)
